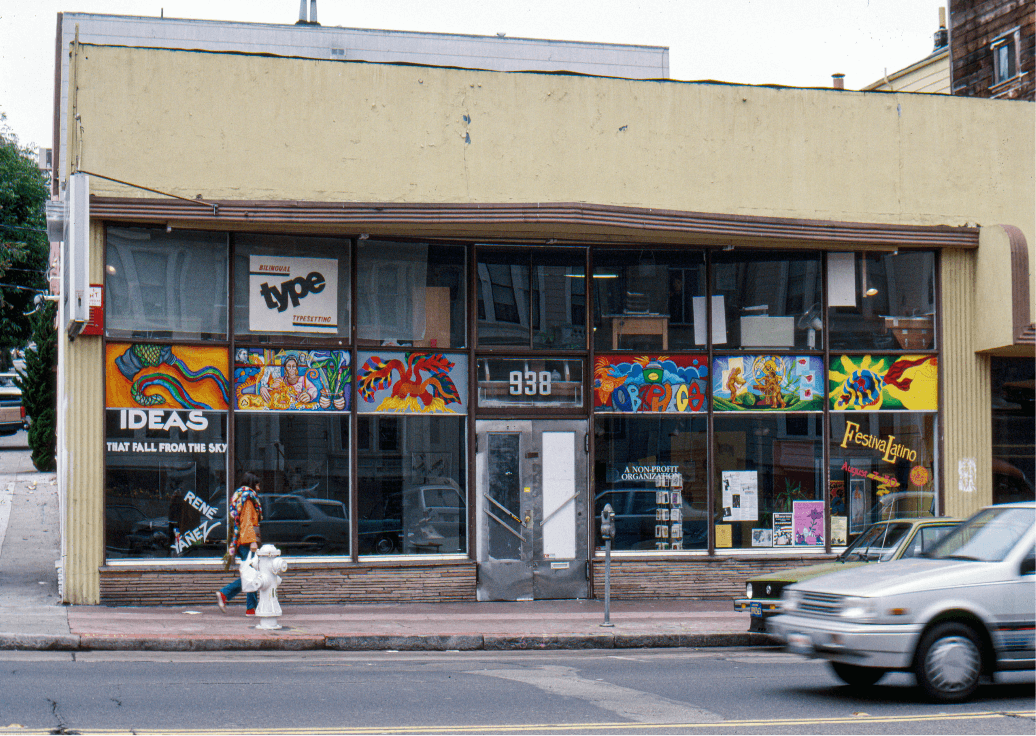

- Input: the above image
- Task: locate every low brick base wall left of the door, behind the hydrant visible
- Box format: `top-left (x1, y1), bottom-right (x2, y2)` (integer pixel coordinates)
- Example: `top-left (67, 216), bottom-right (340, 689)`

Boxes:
top-left (100, 560), bottom-right (476, 605)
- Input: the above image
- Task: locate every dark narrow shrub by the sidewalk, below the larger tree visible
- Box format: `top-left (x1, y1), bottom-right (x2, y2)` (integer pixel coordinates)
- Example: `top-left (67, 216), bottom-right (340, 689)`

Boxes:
top-left (15, 302), bottom-right (58, 473)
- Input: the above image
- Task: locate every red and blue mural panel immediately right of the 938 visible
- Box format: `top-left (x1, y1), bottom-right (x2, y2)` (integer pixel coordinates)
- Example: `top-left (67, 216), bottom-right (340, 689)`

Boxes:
top-left (594, 356), bottom-right (709, 414)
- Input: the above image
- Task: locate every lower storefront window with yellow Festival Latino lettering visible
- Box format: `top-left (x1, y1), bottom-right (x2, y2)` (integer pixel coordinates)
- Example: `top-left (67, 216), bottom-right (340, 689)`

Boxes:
top-left (830, 412), bottom-right (939, 544)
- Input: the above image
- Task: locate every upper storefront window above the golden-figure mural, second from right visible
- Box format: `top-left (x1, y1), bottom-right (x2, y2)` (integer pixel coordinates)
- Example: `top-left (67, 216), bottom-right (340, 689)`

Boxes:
top-left (712, 250), bottom-right (824, 349)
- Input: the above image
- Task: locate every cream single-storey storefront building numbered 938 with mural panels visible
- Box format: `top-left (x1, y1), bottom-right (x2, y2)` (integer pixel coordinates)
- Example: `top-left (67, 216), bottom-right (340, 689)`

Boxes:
top-left (48, 14), bottom-right (1036, 604)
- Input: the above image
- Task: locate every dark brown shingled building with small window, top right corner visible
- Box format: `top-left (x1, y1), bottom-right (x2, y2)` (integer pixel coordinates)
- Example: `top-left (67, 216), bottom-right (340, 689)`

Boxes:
top-left (949, 0), bottom-right (1036, 102)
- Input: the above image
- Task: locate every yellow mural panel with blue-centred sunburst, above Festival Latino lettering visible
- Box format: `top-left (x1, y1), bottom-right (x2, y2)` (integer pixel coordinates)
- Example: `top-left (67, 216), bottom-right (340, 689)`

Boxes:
top-left (828, 356), bottom-right (939, 412)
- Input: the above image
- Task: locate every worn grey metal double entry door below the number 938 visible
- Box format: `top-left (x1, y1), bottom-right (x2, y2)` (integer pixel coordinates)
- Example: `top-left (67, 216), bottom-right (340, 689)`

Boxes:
top-left (476, 420), bottom-right (587, 600)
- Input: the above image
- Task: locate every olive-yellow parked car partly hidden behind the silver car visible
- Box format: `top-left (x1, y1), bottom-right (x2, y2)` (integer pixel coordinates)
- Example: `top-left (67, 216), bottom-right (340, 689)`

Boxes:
top-left (733, 518), bottom-right (960, 631)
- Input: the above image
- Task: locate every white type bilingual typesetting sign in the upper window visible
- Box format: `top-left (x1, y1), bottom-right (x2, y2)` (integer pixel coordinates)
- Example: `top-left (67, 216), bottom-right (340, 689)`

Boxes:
top-left (249, 255), bottom-right (338, 335)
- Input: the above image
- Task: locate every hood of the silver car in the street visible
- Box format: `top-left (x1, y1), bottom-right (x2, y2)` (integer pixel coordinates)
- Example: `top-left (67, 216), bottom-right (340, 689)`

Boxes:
top-left (783, 558), bottom-right (996, 596)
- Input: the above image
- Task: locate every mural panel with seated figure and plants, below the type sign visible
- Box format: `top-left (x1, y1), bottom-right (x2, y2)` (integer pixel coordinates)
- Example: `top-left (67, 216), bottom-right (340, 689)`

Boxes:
top-left (234, 347), bottom-right (352, 412)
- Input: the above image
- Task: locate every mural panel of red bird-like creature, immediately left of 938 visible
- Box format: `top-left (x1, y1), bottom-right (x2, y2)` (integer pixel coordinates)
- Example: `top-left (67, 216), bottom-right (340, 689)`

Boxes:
top-left (356, 350), bottom-right (467, 414)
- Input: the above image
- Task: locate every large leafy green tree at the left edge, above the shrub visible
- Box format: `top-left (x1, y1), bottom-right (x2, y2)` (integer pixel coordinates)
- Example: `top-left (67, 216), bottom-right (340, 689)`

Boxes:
top-left (0, 112), bottom-right (50, 370)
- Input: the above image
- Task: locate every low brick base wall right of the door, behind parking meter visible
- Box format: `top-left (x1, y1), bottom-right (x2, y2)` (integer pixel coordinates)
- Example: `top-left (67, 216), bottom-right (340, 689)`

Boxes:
top-left (593, 555), bottom-right (835, 600)
